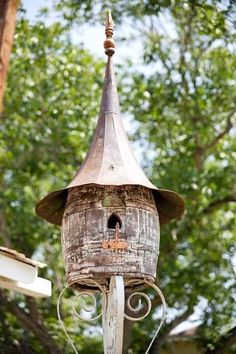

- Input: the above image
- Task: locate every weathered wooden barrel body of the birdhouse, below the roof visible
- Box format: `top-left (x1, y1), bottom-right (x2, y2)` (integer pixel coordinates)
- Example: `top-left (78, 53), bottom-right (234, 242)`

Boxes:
top-left (62, 185), bottom-right (160, 286)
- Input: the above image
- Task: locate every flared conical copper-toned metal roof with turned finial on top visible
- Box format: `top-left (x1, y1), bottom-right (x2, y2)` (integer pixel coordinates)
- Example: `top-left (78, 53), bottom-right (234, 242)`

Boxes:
top-left (36, 14), bottom-right (184, 225)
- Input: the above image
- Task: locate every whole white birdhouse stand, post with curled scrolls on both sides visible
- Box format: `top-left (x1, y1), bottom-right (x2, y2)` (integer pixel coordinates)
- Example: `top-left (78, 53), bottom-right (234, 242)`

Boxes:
top-left (57, 275), bottom-right (166, 354)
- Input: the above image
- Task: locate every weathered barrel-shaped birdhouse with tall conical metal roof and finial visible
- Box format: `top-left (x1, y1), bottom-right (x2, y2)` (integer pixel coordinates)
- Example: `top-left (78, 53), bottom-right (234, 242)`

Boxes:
top-left (36, 15), bottom-right (184, 294)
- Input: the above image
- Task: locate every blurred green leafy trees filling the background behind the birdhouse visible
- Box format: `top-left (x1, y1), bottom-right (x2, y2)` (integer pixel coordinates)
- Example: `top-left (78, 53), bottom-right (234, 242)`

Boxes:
top-left (0, 0), bottom-right (236, 354)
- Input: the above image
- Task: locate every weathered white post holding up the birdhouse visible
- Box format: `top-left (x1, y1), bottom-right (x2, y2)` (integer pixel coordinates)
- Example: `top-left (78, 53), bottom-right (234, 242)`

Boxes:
top-left (102, 275), bottom-right (125, 354)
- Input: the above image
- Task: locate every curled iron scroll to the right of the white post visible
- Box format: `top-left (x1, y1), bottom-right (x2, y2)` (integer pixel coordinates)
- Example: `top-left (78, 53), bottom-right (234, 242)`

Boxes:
top-left (124, 280), bottom-right (166, 354)
